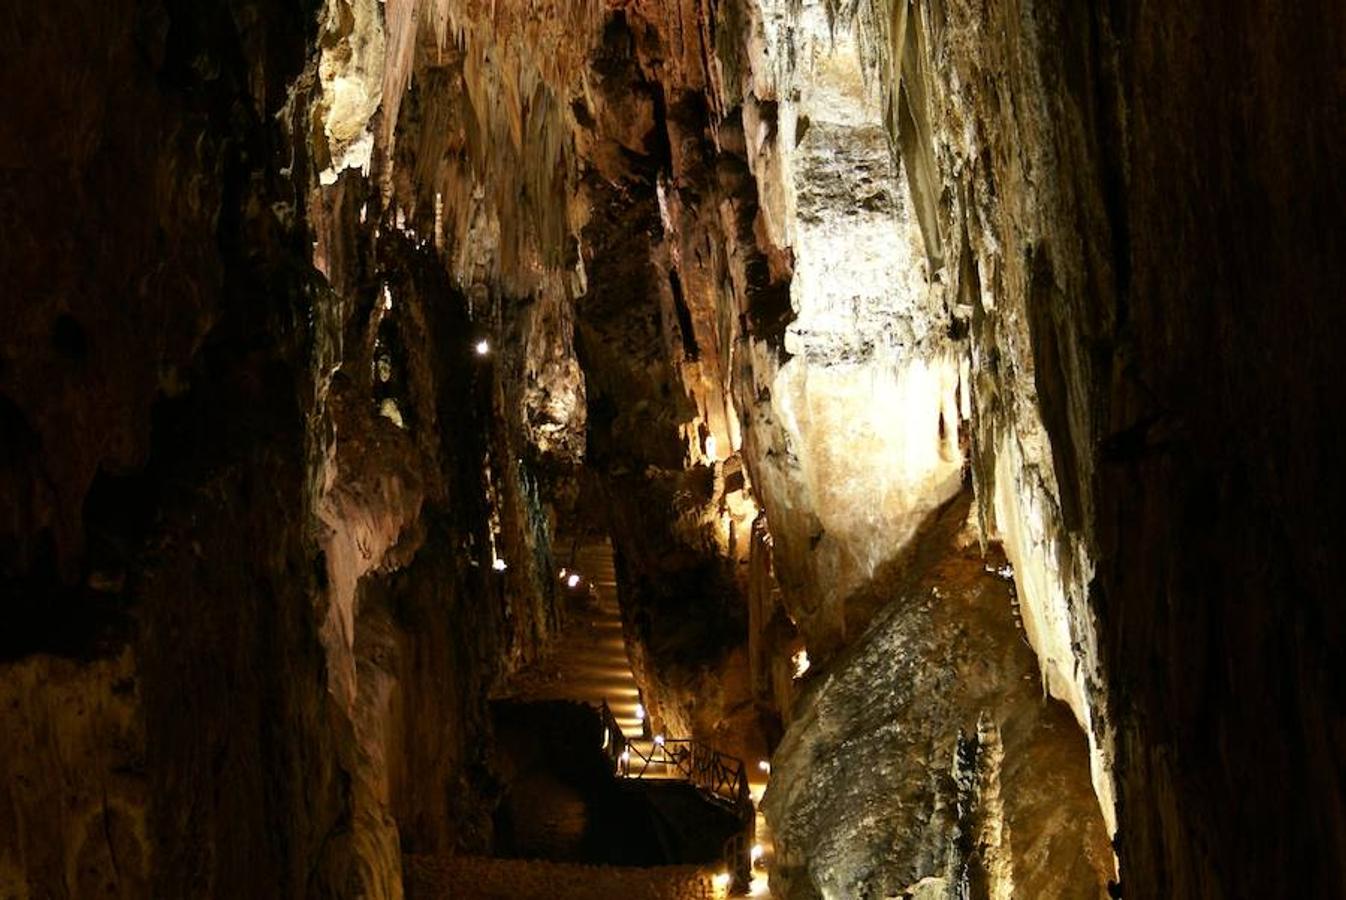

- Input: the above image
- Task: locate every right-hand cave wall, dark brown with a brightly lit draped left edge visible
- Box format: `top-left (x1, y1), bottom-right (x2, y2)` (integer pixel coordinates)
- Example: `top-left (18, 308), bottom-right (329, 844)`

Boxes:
top-left (861, 3), bottom-right (1343, 896)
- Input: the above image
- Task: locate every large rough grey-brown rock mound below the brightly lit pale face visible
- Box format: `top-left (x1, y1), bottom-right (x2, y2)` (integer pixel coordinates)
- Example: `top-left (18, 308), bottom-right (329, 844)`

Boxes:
top-left (765, 499), bottom-right (1112, 899)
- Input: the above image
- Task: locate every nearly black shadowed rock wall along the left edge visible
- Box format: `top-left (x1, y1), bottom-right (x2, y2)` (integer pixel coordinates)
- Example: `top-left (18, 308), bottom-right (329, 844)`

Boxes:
top-left (0, 3), bottom-right (342, 897)
